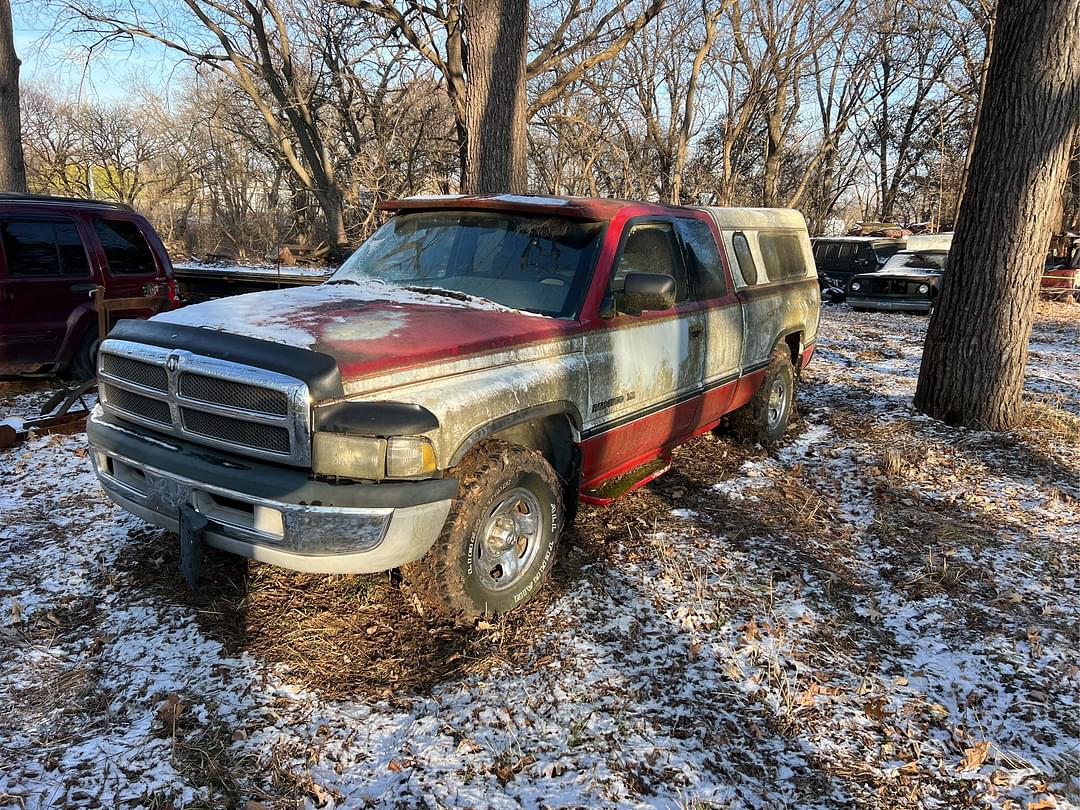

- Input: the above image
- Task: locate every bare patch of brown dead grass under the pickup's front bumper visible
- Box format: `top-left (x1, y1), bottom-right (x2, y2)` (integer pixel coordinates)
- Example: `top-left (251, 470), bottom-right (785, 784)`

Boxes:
top-left (118, 522), bottom-right (580, 701)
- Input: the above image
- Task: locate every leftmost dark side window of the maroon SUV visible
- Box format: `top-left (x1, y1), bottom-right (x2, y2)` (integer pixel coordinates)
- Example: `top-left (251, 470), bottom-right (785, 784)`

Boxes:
top-left (0, 219), bottom-right (90, 278)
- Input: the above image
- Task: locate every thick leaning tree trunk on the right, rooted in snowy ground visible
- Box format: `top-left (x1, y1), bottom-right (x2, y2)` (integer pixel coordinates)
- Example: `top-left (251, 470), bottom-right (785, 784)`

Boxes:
top-left (915, 0), bottom-right (1080, 430)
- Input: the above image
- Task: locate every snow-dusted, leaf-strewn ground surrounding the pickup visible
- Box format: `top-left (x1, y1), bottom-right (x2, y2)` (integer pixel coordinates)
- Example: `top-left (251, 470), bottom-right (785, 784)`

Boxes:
top-left (0, 305), bottom-right (1080, 810)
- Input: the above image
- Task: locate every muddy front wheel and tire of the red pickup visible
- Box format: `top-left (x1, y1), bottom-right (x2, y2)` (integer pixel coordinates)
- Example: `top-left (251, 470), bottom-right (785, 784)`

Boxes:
top-left (402, 441), bottom-right (565, 623)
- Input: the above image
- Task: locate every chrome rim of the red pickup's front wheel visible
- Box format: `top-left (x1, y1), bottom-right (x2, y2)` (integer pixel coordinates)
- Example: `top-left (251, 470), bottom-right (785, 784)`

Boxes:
top-left (473, 487), bottom-right (543, 592)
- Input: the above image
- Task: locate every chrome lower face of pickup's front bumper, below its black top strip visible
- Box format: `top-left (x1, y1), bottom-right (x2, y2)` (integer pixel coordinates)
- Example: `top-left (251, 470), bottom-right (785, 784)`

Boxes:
top-left (92, 447), bottom-right (450, 573)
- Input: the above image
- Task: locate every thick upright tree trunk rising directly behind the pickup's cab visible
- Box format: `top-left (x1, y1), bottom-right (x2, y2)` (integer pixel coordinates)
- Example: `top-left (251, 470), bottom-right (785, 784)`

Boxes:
top-left (462, 0), bottom-right (528, 193)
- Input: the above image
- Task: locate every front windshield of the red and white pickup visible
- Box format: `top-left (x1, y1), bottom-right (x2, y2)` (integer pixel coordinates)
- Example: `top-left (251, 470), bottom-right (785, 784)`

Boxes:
top-left (330, 211), bottom-right (604, 318)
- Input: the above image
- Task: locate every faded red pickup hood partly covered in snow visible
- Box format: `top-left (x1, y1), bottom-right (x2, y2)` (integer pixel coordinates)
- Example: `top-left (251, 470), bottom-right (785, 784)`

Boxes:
top-left (153, 284), bottom-right (577, 382)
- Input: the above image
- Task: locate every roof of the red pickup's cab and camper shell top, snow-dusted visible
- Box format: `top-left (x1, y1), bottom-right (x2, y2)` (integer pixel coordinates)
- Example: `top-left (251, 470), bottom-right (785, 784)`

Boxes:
top-left (379, 194), bottom-right (806, 229)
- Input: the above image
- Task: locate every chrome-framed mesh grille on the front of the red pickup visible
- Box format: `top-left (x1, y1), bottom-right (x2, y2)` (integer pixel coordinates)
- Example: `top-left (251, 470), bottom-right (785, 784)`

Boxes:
top-left (98, 339), bottom-right (311, 467)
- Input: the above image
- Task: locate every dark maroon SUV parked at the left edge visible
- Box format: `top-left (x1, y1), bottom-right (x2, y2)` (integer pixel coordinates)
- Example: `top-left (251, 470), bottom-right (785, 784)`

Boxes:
top-left (0, 193), bottom-right (176, 379)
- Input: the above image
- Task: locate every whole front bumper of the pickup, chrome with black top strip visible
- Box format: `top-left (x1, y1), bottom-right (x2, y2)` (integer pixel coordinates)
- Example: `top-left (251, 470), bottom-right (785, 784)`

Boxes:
top-left (86, 408), bottom-right (457, 573)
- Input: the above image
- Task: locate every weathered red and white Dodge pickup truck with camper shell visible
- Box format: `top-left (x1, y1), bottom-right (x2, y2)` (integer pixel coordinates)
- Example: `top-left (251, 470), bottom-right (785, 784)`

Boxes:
top-left (87, 195), bottom-right (820, 620)
